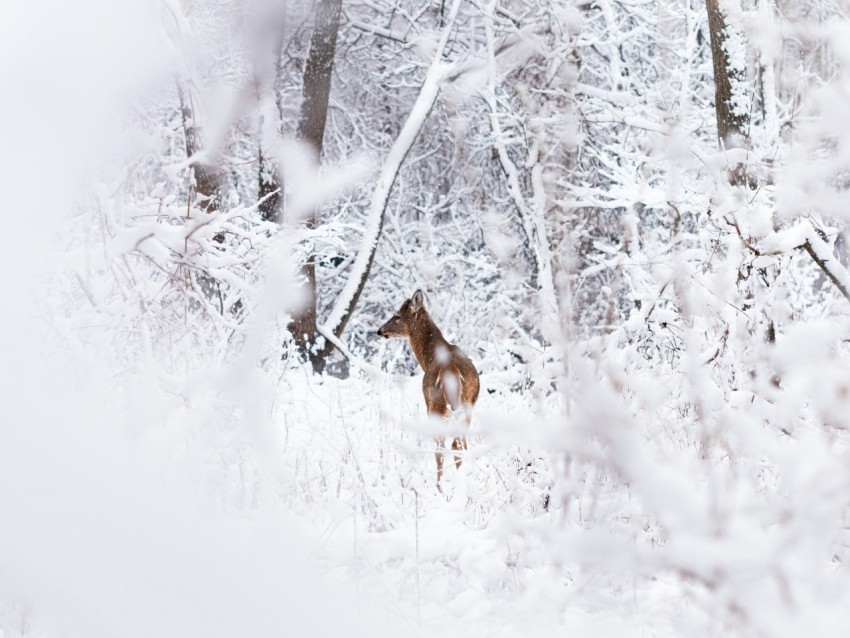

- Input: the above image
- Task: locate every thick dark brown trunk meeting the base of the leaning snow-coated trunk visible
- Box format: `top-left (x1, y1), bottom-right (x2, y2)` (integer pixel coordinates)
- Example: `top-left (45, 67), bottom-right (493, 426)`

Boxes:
top-left (289, 0), bottom-right (342, 372)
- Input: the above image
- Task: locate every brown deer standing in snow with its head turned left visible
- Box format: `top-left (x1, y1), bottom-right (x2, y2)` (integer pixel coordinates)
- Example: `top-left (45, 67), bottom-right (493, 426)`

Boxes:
top-left (378, 290), bottom-right (480, 491)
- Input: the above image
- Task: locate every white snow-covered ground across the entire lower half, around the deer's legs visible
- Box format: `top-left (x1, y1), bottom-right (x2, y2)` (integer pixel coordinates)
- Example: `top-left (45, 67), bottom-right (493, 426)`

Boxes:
top-left (8, 292), bottom-right (850, 638)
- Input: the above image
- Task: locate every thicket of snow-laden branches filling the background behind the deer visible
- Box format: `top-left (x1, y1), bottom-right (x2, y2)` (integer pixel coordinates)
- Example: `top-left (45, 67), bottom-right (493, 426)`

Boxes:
top-left (64, 2), bottom-right (848, 362)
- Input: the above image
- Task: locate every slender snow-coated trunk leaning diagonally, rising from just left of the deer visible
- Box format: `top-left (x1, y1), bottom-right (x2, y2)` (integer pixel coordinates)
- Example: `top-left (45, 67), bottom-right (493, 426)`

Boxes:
top-left (321, 0), bottom-right (460, 336)
